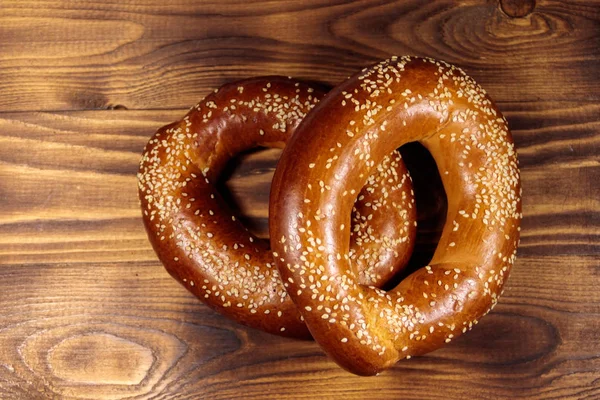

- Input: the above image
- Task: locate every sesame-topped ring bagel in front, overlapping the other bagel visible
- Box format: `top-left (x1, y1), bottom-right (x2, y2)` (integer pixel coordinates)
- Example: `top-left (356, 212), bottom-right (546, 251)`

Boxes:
top-left (270, 57), bottom-right (522, 375)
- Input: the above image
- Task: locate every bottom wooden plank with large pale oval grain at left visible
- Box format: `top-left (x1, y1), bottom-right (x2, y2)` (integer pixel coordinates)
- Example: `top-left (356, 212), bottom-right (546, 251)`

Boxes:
top-left (0, 257), bottom-right (600, 399)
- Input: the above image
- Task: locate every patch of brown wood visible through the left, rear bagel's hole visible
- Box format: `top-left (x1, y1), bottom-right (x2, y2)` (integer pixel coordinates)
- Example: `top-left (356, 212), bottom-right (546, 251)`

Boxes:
top-left (216, 148), bottom-right (282, 239)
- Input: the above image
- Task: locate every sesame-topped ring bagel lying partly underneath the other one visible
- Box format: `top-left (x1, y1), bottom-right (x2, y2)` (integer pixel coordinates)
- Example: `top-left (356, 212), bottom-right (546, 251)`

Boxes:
top-left (138, 77), bottom-right (416, 337)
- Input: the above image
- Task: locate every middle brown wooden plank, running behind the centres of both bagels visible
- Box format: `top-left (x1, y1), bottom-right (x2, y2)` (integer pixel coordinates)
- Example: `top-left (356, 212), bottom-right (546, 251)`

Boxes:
top-left (0, 103), bottom-right (600, 263)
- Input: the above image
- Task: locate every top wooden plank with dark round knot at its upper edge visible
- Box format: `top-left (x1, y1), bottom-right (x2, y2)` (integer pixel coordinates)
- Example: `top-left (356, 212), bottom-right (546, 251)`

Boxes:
top-left (0, 0), bottom-right (600, 111)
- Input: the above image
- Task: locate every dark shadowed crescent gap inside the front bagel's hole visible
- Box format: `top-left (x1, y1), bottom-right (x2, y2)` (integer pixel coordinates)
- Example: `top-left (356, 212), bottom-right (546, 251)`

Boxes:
top-left (384, 142), bottom-right (448, 290)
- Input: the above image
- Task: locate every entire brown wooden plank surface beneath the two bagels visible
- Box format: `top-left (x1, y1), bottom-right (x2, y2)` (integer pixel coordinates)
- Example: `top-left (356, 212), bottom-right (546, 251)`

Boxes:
top-left (0, 0), bottom-right (600, 399)
